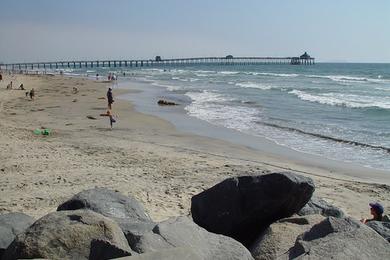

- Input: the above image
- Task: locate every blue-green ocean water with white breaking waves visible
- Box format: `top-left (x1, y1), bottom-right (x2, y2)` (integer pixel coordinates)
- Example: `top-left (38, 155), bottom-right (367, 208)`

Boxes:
top-left (54, 63), bottom-right (390, 170)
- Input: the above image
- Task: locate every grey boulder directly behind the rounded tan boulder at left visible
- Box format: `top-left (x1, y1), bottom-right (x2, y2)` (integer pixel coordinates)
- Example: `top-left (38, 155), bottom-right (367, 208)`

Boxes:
top-left (57, 188), bottom-right (155, 232)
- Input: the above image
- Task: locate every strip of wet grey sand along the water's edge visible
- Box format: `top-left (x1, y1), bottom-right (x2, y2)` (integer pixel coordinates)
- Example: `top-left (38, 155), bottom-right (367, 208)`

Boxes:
top-left (117, 80), bottom-right (390, 185)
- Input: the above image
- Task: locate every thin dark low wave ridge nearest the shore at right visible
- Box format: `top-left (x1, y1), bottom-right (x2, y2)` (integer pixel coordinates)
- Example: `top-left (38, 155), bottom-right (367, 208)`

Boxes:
top-left (257, 122), bottom-right (390, 153)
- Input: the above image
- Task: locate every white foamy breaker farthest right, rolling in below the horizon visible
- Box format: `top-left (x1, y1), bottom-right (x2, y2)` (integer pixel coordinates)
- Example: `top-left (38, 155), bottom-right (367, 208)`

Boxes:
top-left (288, 89), bottom-right (390, 109)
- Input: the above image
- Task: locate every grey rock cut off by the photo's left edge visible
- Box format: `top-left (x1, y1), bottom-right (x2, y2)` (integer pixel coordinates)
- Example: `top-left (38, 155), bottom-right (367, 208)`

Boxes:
top-left (0, 212), bottom-right (35, 259)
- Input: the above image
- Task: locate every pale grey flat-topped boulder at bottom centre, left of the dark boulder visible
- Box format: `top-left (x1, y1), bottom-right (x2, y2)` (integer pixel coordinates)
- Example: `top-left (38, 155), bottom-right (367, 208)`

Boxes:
top-left (127, 217), bottom-right (253, 259)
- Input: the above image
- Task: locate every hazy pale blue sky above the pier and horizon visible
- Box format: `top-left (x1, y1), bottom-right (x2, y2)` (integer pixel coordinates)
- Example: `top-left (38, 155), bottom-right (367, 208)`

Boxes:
top-left (0, 0), bottom-right (390, 62)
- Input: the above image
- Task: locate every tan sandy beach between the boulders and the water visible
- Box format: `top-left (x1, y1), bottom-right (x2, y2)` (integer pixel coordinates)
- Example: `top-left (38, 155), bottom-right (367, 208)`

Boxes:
top-left (0, 75), bottom-right (390, 221)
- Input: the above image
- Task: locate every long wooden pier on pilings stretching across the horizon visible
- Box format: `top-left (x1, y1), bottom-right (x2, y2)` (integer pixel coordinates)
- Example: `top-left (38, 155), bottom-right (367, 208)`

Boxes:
top-left (0, 52), bottom-right (315, 70)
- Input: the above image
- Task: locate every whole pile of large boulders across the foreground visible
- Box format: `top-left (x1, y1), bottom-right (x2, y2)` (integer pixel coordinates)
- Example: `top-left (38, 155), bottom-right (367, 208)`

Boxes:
top-left (0, 173), bottom-right (390, 260)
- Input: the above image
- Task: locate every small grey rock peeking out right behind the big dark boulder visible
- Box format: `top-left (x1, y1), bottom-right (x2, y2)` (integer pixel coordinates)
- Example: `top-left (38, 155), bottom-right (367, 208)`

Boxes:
top-left (298, 196), bottom-right (344, 218)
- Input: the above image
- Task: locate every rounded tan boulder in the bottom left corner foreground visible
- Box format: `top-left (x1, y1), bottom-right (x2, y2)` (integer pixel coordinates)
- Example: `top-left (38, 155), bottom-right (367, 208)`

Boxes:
top-left (3, 210), bottom-right (132, 260)
